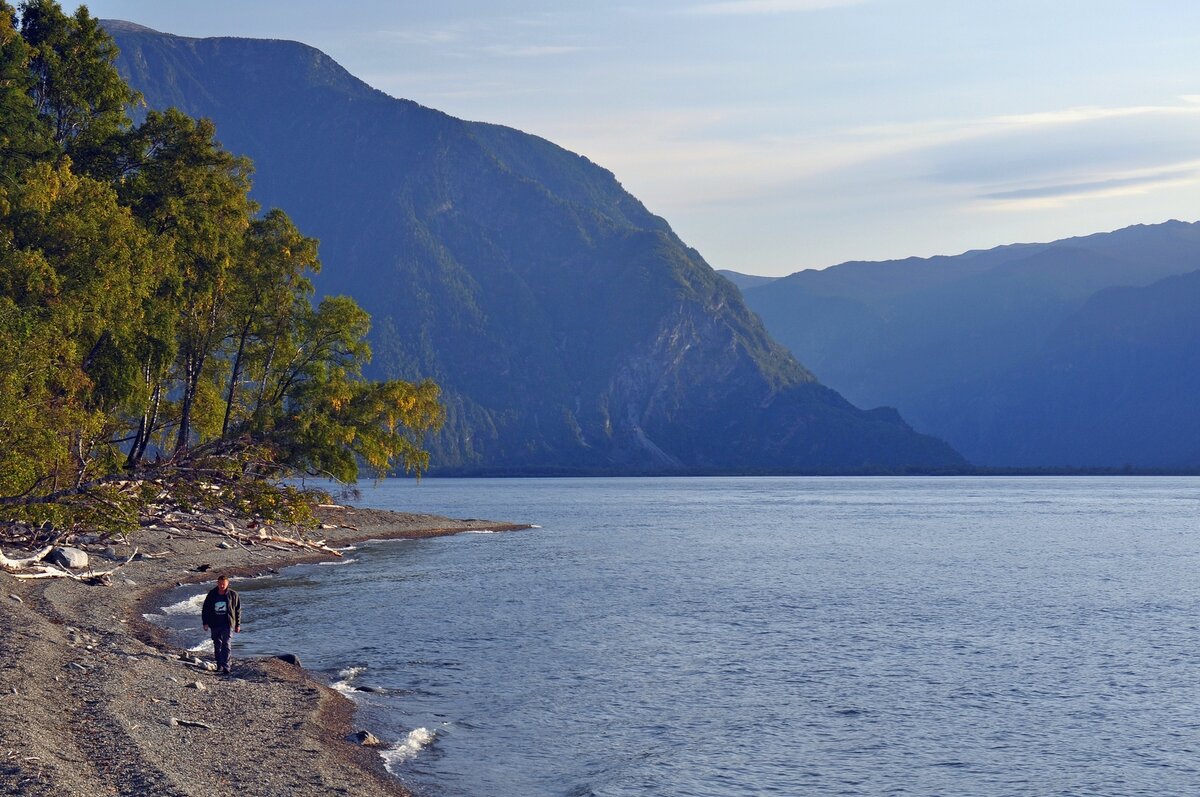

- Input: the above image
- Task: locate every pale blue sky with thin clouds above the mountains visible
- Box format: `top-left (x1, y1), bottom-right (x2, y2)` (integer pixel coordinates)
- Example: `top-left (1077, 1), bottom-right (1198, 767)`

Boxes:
top-left (79, 0), bottom-right (1200, 276)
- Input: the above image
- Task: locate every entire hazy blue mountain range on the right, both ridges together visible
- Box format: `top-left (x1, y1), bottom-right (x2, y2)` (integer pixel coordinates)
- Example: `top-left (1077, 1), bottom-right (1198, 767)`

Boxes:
top-left (729, 221), bottom-right (1200, 467)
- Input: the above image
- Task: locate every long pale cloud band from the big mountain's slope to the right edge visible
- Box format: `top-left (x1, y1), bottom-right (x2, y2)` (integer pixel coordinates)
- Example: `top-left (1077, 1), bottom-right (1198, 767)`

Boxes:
top-left (541, 98), bottom-right (1200, 226)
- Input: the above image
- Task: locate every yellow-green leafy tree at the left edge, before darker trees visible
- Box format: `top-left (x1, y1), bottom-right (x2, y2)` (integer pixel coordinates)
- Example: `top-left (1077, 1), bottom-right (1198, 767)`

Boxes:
top-left (0, 162), bottom-right (151, 499)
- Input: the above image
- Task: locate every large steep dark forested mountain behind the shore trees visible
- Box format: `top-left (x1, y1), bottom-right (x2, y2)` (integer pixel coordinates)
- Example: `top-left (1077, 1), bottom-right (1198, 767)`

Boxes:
top-left (104, 22), bottom-right (962, 473)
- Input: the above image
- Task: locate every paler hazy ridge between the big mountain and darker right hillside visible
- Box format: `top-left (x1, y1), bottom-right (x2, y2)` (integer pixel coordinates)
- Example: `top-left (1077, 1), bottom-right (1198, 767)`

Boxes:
top-left (744, 221), bottom-right (1200, 466)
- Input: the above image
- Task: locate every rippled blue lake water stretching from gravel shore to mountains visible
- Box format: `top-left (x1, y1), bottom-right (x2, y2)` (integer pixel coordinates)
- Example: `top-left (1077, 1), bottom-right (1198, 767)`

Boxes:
top-left (152, 478), bottom-right (1200, 797)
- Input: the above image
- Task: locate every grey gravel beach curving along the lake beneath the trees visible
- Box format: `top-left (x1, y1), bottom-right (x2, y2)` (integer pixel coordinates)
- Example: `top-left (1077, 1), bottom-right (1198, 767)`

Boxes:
top-left (0, 508), bottom-right (527, 797)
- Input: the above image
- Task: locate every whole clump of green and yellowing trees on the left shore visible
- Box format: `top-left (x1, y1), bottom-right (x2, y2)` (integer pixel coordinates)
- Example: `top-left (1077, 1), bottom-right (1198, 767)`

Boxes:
top-left (0, 0), bottom-right (443, 535)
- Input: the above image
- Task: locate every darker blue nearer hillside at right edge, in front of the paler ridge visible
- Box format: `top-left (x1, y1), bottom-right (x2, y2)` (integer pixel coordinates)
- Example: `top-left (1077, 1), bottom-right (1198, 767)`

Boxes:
top-left (929, 271), bottom-right (1200, 468)
